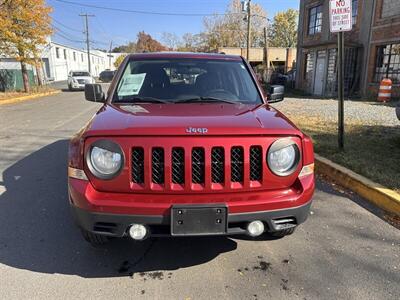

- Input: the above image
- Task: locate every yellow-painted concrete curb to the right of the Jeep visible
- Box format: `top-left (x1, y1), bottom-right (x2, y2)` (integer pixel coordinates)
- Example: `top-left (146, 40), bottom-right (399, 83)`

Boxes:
top-left (315, 154), bottom-right (400, 216)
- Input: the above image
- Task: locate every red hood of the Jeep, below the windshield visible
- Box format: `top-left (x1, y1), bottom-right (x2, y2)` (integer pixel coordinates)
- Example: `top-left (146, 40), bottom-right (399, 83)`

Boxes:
top-left (86, 103), bottom-right (302, 136)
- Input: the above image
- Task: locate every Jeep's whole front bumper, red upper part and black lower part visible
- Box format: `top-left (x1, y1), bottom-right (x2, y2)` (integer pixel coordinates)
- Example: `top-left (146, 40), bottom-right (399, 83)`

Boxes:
top-left (69, 175), bottom-right (315, 237)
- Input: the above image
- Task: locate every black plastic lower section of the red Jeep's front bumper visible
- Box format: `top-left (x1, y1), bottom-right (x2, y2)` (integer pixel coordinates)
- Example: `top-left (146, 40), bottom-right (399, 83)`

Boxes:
top-left (71, 201), bottom-right (312, 237)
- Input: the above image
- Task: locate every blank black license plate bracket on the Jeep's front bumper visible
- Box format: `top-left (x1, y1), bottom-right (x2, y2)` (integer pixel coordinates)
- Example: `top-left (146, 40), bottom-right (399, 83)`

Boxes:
top-left (171, 205), bottom-right (228, 236)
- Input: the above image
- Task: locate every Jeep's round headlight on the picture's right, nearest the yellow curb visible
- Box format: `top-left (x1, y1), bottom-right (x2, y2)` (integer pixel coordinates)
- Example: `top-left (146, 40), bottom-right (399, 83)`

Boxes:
top-left (267, 138), bottom-right (300, 176)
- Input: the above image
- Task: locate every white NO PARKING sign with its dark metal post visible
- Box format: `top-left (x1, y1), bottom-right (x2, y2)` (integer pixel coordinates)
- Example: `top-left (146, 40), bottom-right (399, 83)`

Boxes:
top-left (329, 0), bottom-right (353, 150)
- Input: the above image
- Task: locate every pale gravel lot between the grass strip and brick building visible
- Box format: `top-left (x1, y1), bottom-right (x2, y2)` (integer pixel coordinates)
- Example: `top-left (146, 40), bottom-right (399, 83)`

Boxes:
top-left (273, 97), bottom-right (400, 126)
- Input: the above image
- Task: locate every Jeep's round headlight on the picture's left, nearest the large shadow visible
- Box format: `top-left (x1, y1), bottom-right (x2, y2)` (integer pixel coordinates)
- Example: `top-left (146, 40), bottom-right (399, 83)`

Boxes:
top-left (86, 140), bottom-right (124, 179)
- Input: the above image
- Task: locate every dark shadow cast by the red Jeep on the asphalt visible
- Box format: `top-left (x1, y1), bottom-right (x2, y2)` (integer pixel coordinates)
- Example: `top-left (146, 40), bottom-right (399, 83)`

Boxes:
top-left (0, 140), bottom-right (237, 278)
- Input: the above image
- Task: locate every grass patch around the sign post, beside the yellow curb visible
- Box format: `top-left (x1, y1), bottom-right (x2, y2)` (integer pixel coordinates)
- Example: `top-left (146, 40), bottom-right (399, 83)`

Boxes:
top-left (288, 114), bottom-right (400, 192)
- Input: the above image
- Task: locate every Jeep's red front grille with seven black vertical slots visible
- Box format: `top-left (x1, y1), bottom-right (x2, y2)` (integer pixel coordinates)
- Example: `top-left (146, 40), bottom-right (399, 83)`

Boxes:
top-left (131, 145), bottom-right (265, 190)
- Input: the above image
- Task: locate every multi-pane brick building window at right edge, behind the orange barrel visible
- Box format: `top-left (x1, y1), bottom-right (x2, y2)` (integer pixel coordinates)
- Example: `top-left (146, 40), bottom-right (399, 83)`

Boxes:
top-left (374, 43), bottom-right (400, 83)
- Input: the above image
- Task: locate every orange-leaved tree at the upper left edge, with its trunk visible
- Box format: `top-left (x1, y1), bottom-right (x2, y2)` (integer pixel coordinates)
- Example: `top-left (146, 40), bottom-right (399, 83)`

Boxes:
top-left (0, 0), bottom-right (52, 93)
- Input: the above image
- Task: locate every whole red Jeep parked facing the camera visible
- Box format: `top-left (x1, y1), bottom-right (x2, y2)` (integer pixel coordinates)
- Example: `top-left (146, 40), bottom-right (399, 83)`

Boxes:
top-left (68, 53), bottom-right (314, 244)
